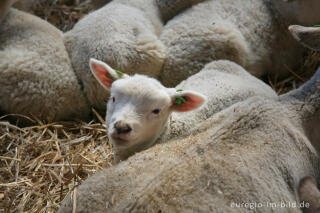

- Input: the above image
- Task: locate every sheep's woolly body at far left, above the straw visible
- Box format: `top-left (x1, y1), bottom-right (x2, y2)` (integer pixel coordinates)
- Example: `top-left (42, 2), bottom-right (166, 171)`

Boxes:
top-left (0, 8), bottom-right (90, 122)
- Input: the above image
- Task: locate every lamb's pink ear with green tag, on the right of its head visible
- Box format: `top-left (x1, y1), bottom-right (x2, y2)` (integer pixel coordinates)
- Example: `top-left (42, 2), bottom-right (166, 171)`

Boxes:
top-left (171, 90), bottom-right (206, 112)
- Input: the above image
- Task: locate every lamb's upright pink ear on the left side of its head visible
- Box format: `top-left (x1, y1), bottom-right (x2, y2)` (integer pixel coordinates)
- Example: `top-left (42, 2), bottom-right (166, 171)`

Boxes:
top-left (89, 58), bottom-right (128, 90)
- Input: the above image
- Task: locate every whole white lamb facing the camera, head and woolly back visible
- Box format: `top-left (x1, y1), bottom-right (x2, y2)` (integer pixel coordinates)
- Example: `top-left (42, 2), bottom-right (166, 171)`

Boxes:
top-left (90, 59), bottom-right (276, 162)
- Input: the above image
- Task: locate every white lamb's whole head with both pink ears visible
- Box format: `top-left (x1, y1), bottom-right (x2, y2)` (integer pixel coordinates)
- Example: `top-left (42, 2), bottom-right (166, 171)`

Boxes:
top-left (90, 59), bottom-right (205, 160)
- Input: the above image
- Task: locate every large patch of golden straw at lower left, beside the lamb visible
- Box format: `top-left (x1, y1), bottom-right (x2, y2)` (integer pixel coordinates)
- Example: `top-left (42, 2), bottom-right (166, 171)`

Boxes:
top-left (0, 110), bottom-right (113, 212)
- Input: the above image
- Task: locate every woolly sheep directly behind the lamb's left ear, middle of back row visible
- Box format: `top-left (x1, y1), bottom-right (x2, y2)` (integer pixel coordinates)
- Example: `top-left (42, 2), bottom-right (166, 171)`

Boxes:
top-left (64, 0), bottom-right (203, 114)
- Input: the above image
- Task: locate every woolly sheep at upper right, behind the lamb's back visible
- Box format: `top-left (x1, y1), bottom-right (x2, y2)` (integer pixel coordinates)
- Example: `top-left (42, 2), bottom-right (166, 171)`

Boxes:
top-left (160, 0), bottom-right (320, 86)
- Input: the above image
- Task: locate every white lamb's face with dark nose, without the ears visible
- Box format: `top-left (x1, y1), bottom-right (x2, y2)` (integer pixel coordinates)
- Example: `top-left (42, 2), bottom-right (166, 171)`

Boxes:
top-left (106, 75), bottom-right (174, 149)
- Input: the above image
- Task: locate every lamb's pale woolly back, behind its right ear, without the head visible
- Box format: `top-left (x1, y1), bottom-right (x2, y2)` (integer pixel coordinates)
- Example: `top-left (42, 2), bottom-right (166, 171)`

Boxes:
top-left (159, 60), bottom-right (277, 142)
